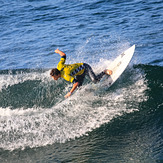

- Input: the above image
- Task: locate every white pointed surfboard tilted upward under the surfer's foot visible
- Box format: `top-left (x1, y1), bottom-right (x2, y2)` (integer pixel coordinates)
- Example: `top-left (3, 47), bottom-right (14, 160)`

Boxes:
top-left (107, 45), bottom-right (135, 86)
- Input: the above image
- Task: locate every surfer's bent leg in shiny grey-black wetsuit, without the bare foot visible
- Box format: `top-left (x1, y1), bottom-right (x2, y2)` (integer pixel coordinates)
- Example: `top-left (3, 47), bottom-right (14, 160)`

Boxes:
top-left (84, 63), bottom-right (105, 83)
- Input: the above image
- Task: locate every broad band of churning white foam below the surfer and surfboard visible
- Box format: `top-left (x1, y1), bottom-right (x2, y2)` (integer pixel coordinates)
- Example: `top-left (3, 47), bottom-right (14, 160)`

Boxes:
top-left (0, 73), bottom-right (147, 150)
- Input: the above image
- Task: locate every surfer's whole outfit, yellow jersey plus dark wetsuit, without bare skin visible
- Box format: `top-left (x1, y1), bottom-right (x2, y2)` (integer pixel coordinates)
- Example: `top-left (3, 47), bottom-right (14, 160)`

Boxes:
top-left (57, 56), bottom-right (105, 86)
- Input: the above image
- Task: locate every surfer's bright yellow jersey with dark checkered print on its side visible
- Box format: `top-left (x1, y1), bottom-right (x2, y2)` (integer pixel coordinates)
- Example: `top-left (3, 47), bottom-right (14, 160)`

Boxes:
top-left (57, 57), bottom-right (84, 83)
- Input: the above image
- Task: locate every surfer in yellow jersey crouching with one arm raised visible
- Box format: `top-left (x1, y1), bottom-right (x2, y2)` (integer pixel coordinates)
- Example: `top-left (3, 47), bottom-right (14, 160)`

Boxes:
top-left (50, 49), bottom-right (112, 98)
